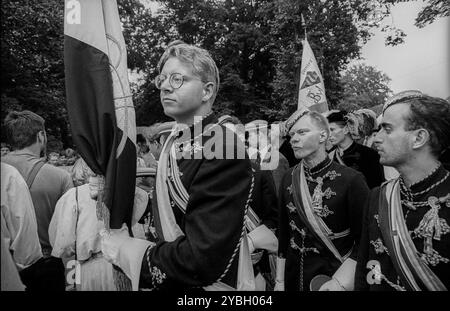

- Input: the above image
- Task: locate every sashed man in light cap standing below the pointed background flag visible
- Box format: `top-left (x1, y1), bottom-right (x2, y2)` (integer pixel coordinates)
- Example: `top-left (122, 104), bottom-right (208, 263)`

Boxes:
top-left (276, 110), bottom-right (369, 291)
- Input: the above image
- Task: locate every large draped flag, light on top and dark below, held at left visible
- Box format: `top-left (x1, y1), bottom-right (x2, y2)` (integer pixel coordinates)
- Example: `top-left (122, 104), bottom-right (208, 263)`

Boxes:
top-left (64, 0), bottom-right (136, 229)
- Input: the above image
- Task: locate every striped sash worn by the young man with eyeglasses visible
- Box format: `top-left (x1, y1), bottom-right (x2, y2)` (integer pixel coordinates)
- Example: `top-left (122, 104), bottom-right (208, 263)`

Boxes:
top-left (156, 126), bottom-right (255, 291)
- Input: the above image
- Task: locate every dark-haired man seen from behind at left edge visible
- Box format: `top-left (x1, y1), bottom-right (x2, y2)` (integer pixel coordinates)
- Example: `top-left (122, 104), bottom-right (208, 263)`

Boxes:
top-left (2, 110), bottom-right (73, 290)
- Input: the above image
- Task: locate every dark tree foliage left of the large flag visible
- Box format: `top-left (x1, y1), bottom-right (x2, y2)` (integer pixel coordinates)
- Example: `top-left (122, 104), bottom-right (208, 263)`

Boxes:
top-left (1, 0), bottom-right (69, 151)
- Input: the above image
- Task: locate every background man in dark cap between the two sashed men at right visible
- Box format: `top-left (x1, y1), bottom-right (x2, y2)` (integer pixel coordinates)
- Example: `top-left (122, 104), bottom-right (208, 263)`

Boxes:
top-left (327, 111), bottom-right (384, 188)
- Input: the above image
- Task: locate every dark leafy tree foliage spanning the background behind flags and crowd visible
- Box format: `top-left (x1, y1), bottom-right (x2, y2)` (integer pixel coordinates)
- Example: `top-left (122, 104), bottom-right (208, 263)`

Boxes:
top-left (1, 0), bottom-right (449, 147)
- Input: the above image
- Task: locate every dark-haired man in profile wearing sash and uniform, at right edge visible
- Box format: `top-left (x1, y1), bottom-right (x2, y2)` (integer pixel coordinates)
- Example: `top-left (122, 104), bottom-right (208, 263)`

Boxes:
top-left (355, 91), bottom-right (450, 291)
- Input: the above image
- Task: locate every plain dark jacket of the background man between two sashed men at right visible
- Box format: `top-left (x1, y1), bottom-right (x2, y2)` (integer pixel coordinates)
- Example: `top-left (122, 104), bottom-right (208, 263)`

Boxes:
top-left (334, 142), bottom-right (384, 189)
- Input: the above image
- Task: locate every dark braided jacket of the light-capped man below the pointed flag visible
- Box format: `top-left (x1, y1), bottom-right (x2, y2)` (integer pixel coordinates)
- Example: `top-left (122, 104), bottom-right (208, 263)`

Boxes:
top-left (278, 158), bottom-right (369, 291)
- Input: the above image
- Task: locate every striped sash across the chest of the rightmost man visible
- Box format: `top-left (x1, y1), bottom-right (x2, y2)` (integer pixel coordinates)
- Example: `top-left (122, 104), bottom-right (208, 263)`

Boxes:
top-left (378, 178), bottom-right (447, 291)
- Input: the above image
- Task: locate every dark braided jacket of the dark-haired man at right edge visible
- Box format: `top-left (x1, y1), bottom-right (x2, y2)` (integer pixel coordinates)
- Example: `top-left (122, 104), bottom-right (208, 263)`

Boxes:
top-left (355, 166), bottom-right (450, 291)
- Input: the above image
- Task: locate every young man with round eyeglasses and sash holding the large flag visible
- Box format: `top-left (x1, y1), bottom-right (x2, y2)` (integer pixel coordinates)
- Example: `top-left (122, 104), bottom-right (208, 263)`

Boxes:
top-left (103, 42), bottom-right (257, 290)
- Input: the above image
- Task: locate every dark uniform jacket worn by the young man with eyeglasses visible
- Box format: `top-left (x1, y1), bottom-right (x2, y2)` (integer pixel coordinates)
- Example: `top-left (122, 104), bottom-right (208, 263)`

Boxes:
top-left (140, 115), bottom-right (252, 290)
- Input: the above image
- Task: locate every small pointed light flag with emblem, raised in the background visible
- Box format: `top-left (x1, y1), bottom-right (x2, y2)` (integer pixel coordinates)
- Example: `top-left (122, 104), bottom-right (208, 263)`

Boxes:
top-left (297, 38), bottom-right (328, 113)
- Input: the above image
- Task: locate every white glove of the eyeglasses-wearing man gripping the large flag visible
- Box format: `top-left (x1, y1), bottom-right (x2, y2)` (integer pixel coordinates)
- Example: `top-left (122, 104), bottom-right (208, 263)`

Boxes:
top-left (100, 224), bottom-right (153, 290)
